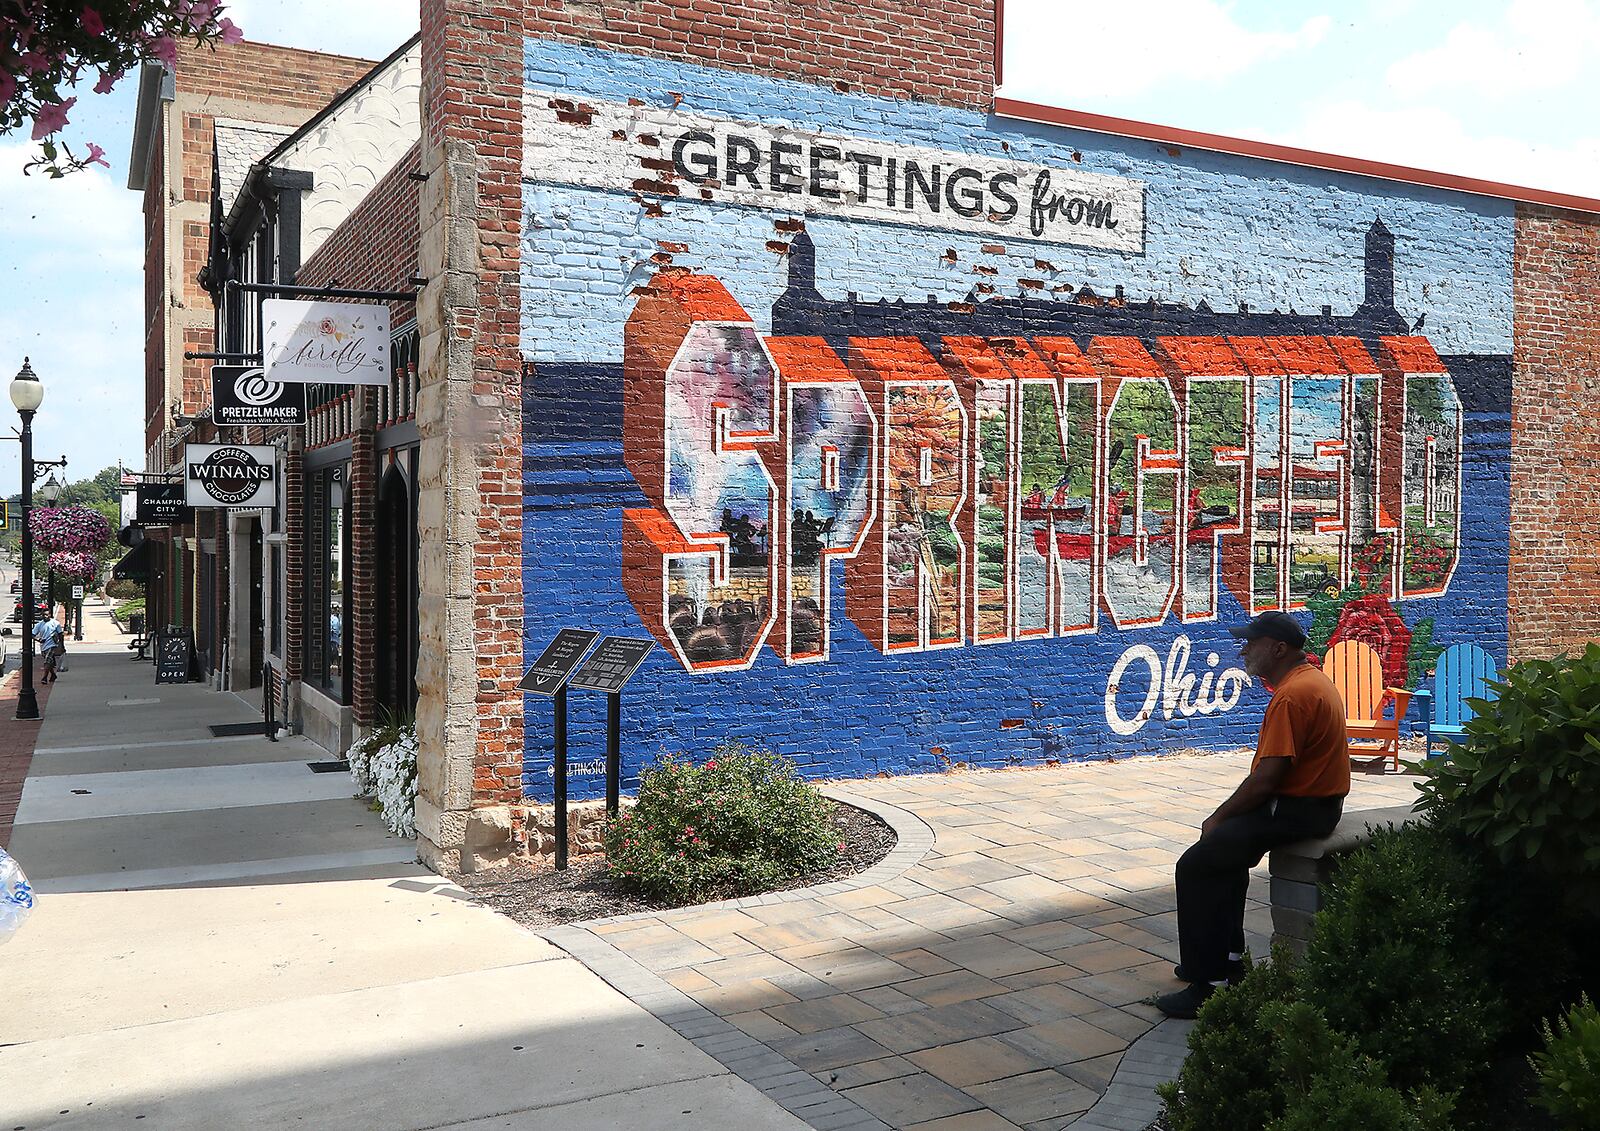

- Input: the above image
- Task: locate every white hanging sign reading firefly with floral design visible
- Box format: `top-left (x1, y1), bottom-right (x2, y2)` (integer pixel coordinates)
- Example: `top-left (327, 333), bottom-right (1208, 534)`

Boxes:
top-left (261, 299), bottom-right (389, 386)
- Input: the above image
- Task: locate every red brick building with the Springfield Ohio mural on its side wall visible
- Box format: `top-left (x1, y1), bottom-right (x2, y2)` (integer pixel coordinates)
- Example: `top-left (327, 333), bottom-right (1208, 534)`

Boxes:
top-left (124, 0), bottom-right (1600, 867)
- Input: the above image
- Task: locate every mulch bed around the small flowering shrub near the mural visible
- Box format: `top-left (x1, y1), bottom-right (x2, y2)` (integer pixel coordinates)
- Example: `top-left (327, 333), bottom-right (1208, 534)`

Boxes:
top-left (459, 801), bottom-right (896, 928)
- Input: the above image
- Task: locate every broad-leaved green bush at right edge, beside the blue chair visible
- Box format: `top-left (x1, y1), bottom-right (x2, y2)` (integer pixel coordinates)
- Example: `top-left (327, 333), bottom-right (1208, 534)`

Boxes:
top-left (1421, 645), bottom-right (1600, 878)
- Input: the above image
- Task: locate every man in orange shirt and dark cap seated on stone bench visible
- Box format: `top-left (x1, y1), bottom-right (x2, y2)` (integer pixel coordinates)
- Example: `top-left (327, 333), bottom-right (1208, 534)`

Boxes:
top-left (1155, 609), bottom-right (1350, 1019)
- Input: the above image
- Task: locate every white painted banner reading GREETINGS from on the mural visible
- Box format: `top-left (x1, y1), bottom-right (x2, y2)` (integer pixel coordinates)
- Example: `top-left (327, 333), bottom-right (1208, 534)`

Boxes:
top-left (523, 91), bottom-right (1144, 253)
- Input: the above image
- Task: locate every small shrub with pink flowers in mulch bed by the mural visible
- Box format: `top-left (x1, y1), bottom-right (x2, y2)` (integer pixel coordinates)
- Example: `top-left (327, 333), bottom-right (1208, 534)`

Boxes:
top-left (605, 744), bottom-right (842, 904)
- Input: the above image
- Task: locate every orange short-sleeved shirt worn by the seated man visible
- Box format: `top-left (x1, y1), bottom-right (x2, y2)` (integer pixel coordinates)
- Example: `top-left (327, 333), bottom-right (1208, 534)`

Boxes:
top-left (1250, 664), bottom-right (1350, 797)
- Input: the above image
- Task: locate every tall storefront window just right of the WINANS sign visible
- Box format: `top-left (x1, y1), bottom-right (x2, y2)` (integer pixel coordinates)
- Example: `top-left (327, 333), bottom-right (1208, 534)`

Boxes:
top-left (304, 464), bottom-right (350, 702)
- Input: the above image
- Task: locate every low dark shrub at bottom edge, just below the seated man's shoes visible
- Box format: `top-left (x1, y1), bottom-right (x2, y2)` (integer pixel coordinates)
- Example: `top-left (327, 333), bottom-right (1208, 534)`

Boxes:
top-left (1157, 952), bottom-right (1296, 1131)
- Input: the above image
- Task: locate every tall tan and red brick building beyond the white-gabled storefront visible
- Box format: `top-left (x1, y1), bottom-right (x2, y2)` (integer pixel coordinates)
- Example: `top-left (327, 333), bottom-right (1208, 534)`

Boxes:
top-left (128, 43), bottom-right (382, 688)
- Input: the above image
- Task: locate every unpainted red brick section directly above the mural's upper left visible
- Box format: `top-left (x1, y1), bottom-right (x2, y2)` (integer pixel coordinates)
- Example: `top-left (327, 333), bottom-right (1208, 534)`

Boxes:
top-left (526, 0), bottom-right (995, 109)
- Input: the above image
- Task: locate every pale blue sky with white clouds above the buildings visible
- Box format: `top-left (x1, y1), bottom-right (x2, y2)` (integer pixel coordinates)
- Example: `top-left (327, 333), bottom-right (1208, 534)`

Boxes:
top-left (0, 0), bottom-right (1600, 494)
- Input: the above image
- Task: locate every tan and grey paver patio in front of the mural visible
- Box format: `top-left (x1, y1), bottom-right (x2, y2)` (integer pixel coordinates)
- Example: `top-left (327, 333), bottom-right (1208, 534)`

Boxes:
top-left (547, 755), bottom-right (1416, 1131)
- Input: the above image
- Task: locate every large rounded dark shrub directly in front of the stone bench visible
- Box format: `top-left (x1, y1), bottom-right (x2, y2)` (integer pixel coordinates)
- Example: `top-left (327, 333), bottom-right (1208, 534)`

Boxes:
top-left (1301, 824), bottom-right (1501, 1093)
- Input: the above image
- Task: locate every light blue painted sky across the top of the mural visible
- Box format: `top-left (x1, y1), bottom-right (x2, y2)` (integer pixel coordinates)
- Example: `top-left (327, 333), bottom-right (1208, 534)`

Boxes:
top-left (523, 42), bottom-right (1514, 362)
